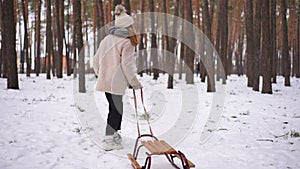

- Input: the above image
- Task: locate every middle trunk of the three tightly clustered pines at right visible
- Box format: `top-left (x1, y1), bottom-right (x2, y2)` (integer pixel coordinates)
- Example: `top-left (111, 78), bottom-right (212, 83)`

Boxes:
top-left (253, 0), bottom-right (266, 91)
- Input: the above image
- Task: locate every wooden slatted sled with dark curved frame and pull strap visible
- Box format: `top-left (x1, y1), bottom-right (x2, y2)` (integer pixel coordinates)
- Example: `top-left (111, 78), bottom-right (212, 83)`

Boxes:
top-left (127, 89), bottom-right (195, 169)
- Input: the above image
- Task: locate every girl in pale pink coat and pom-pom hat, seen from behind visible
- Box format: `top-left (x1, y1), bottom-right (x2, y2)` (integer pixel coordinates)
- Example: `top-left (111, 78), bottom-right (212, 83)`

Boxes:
top-left (93, 5), bottom-right (142, 151)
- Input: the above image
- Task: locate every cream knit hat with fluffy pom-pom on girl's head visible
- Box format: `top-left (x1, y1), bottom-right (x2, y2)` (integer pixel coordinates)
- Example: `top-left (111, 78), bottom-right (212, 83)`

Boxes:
top-left (115, 5), bottom-right (134, 28)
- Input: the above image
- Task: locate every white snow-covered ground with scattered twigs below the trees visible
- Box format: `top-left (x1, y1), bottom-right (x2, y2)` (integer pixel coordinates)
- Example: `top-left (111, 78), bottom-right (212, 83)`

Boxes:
top-left (0, 75), bottom-right (300, 169)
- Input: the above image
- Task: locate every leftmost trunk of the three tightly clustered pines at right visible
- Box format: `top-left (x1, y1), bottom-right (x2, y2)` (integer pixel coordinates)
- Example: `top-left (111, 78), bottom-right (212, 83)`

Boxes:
top-left (245, 0), bottom-right (254, 87)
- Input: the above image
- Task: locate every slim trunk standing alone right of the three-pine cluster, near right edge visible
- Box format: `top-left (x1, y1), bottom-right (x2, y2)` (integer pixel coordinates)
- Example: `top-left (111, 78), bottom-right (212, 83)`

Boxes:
top-left (280, 0), bottom-right (291, 86)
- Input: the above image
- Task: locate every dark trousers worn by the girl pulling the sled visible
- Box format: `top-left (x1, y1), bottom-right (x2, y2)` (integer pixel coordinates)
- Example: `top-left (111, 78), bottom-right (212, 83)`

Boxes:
top-left (105, 92), bottom-right (123, 135)
